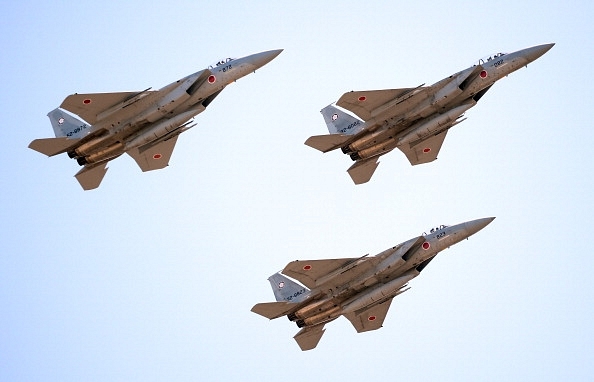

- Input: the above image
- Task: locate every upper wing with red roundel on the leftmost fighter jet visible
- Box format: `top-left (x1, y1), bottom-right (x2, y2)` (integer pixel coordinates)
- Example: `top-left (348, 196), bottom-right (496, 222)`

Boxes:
top-left (60, 91), bottom-right (156, 125)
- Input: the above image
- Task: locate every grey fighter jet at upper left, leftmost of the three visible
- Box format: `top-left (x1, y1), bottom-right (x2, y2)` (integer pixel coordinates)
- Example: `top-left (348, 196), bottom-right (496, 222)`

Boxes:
top-left (29, 49), bottom-right (282, 190)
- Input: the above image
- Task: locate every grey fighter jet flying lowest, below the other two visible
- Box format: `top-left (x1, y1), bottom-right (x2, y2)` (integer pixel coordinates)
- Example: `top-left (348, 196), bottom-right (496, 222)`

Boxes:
top-left (252, 217), bottom-right (495, 350)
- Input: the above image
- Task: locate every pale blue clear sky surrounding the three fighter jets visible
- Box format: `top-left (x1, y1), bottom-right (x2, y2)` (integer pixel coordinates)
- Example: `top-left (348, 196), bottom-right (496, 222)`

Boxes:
top-left (0, 0), bottom-right (594, 381)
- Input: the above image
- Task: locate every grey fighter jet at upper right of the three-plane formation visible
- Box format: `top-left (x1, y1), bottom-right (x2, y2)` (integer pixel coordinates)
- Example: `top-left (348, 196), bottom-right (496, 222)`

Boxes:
top-left (305, 44), bottom-right (555, 184)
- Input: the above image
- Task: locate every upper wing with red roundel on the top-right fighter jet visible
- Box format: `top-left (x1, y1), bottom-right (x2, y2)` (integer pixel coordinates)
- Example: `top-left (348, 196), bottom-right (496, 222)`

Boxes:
top-left (336, 86), bottom-right (427, 121)
